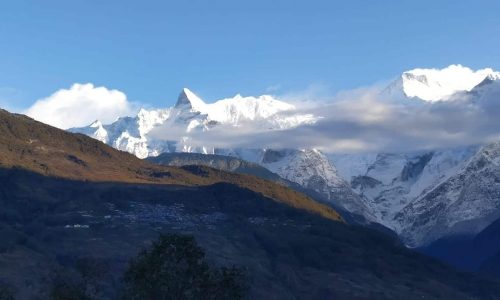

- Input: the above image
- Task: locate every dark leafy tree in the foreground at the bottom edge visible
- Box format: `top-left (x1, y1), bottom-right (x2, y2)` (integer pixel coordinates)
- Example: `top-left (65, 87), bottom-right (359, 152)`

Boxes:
top-left (124, 234), bottom-right (246, 300)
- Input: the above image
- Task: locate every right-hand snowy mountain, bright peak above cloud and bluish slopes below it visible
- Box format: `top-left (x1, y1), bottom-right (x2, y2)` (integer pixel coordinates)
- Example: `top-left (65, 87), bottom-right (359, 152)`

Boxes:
top-left (329, 65), bottom-right (500, 247)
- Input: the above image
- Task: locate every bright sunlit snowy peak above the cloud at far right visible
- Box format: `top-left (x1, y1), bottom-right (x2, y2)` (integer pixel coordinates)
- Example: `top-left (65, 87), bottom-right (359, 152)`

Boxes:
top-left (401, 65), bottom-right (500, 102)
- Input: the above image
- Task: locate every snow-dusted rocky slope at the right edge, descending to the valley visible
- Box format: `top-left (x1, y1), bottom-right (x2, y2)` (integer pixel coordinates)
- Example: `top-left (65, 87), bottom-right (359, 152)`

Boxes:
top-left (396, 142), bottom-right (500, 246)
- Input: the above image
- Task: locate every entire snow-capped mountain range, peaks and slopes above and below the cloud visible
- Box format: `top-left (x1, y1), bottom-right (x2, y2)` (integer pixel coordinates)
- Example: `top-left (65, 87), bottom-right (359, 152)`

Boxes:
top-left (71, 65), bottom-right (500, 246)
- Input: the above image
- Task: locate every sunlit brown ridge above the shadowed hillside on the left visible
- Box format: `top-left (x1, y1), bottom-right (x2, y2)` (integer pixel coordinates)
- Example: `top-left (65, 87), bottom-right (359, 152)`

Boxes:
top-left (0, 110), bottom-right (342, 221)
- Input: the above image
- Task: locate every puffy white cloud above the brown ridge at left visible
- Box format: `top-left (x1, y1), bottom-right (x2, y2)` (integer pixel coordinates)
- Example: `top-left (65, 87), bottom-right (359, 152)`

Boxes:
top-left (23, 83), bottom-right (134, 129)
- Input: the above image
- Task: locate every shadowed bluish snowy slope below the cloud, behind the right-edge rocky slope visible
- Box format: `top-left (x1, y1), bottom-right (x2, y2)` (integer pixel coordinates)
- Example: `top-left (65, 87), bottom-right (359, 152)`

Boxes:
top-left (334, 147), bottom-right (477, 232)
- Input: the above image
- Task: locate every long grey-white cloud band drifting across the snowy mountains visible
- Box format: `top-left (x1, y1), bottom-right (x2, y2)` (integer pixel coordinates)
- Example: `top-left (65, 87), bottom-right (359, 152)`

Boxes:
top-left (153, 83), bottom-right (500, 152)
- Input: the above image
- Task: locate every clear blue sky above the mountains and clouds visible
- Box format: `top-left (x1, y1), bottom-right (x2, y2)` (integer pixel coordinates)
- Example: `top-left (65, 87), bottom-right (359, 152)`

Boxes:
top-left (0, 0), bottom-right (500, 107)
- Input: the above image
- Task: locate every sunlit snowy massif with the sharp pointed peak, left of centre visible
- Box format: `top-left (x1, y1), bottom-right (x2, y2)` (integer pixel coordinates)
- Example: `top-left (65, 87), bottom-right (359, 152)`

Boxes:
top-left (70, 88), bottom-right (316, 158)
